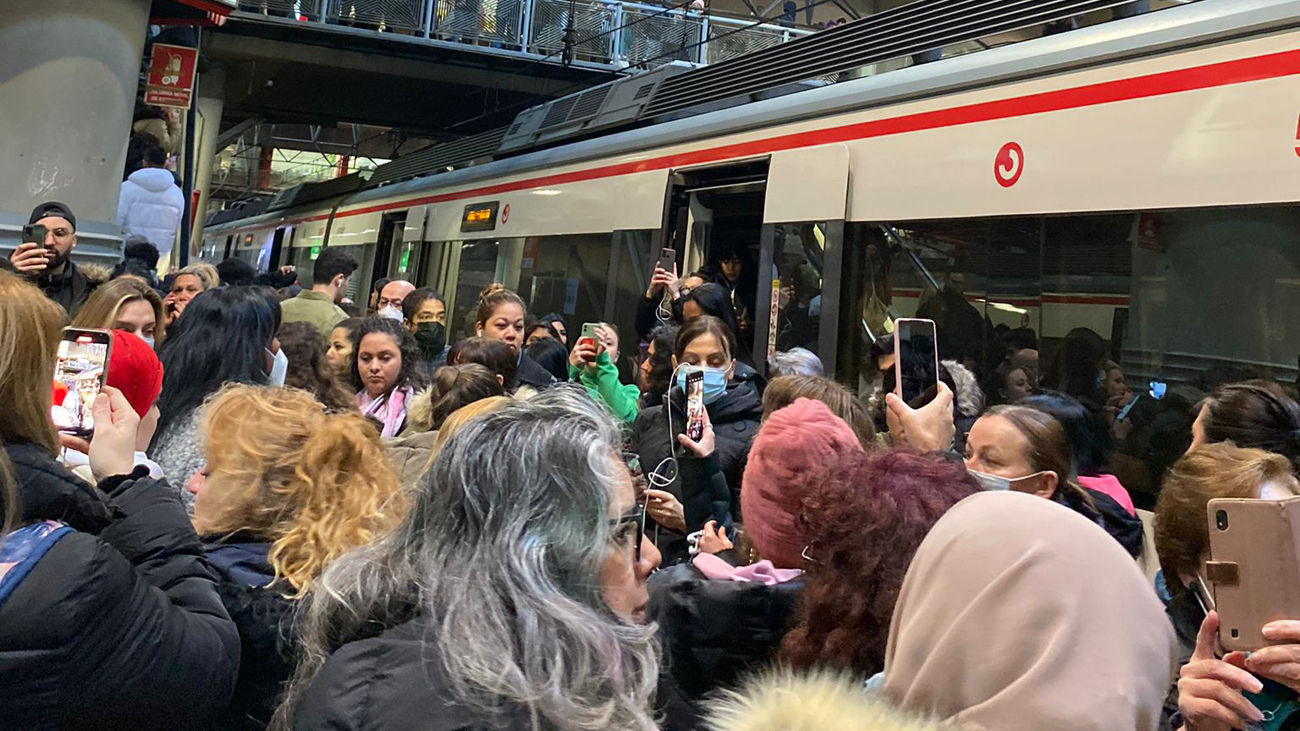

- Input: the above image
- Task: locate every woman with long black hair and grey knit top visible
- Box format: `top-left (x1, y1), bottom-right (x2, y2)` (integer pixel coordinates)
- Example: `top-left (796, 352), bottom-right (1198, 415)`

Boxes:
top-left (148, 287), bottom-right (280, 510)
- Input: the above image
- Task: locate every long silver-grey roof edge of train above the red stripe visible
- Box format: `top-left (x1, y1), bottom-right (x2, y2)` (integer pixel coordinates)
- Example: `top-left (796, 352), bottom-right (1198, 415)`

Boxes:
top-left (208, 0), bottom-right (1300, 230)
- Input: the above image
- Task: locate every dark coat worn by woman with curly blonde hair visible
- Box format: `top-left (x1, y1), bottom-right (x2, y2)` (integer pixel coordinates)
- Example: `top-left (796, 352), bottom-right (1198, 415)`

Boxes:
top-left (205, 535), bottom-right (298, 730)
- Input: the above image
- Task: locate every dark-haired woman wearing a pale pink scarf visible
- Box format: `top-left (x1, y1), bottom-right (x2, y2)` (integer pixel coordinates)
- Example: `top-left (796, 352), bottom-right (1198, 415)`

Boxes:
top-left (351, 312), bottom-right (425, 437)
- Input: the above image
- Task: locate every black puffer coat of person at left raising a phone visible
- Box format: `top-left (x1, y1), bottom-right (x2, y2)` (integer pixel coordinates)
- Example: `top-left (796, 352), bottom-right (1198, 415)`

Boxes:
top-left (0, 445), bottom-right (239, 728)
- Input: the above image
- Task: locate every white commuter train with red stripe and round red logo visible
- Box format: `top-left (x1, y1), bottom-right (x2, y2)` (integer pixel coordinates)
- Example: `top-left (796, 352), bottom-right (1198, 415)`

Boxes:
top-left (203, 0), bottom-right (1300, 381)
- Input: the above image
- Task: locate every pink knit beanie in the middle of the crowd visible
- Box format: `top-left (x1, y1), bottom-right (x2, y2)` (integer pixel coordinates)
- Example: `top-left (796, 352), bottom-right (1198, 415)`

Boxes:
top-left (740, 398), bottom-right (862, 568)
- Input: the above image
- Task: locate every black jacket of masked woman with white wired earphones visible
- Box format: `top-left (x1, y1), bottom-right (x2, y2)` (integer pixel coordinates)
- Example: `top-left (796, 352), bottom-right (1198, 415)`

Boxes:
top-left (629, 380), bottom-right (763, 566)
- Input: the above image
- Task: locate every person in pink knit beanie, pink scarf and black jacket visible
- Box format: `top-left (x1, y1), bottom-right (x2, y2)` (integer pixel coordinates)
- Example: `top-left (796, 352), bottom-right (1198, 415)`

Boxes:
top-left (647, 398), bottom-right (863, 698)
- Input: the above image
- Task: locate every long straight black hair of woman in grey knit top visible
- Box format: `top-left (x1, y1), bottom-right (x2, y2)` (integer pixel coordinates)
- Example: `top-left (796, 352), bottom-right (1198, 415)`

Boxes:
top-left (153, 287), bottom-right (280, 444)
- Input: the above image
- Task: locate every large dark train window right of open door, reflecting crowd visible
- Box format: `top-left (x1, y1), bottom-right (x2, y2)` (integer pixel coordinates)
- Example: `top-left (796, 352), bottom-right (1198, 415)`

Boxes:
top-left (837, 206), bottom-right (1300, 506)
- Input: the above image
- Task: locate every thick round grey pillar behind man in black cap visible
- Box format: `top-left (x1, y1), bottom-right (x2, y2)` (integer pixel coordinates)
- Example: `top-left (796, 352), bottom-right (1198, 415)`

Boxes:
top-left (0, 0), bottom-right (150, 259)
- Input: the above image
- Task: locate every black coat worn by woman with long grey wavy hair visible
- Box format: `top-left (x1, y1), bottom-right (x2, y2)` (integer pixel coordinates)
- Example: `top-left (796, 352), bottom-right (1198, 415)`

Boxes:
top-left (294, 619), bottom-right (694, 731)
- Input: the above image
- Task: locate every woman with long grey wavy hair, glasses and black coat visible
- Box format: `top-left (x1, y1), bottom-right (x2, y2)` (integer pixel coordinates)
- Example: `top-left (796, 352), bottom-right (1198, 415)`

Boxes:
top-left (274, 388), bottom-right (659, 730)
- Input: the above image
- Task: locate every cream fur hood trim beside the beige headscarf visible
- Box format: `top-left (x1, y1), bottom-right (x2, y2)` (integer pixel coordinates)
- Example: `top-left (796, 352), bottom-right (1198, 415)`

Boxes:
top-left (705, 670), bottom-right (940, 731)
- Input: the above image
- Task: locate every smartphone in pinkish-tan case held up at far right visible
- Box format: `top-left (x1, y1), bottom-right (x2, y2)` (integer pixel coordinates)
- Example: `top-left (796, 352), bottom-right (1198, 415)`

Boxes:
top-left (1205, 497), bottom-right (1300, 652)
